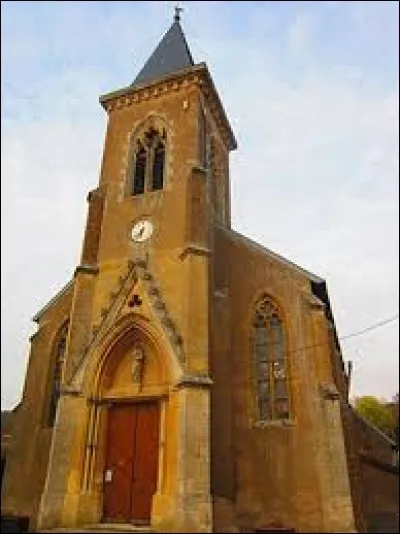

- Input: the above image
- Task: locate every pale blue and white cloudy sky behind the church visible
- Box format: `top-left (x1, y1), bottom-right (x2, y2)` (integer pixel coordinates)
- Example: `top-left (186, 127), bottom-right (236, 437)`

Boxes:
top-left (1, 1), bottom-right (399, 409)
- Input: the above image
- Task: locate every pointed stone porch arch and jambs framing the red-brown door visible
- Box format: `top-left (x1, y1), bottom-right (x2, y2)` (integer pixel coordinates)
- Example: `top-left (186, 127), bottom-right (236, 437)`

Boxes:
top-left (76, 313), bottom-right (183, 521)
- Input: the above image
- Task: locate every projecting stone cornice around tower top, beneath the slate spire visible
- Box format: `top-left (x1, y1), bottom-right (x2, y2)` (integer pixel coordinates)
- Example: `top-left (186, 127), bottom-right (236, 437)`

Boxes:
top-left (99, 63), bottom-right (237, 150)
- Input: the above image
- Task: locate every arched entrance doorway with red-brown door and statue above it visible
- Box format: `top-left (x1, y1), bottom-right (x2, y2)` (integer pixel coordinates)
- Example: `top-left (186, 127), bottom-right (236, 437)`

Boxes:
top-left (86, 325), bottom-right (169, 525)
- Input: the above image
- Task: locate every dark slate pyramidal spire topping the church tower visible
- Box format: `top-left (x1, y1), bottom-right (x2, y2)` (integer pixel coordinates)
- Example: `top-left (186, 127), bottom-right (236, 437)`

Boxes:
top-left (132, 6), bottom-right (194, 86)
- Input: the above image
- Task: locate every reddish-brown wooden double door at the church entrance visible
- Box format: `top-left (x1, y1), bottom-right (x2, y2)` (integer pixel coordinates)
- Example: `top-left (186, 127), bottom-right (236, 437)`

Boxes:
top-left (103, 402), bottom-right (159, 524)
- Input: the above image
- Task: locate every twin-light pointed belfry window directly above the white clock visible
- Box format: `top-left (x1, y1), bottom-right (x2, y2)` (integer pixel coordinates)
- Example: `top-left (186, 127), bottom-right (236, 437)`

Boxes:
top-left (132, 126), bottom-right (166, 195)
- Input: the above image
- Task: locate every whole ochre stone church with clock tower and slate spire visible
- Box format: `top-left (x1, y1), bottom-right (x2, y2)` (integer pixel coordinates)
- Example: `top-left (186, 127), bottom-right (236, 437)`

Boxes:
top-left (2, 9), bottom-right (398, 532)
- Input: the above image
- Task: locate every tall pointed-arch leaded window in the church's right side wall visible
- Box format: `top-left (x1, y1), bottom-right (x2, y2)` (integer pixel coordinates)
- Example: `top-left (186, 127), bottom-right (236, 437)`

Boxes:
top-left (253, 294), bottom-right (289, 421)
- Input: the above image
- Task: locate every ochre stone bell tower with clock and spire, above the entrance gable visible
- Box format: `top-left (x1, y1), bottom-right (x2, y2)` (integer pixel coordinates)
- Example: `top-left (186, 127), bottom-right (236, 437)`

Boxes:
top-left (67, 8), bottom-right (236, 382)
